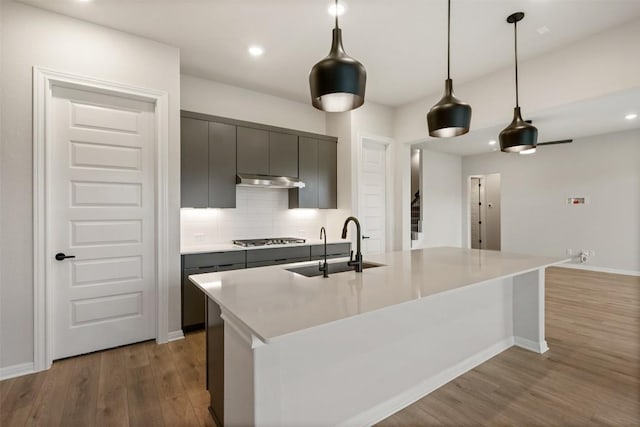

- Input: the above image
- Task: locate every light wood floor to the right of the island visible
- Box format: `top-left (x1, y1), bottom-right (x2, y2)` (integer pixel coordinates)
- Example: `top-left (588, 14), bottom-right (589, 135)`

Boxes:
top-left (378, 268), bottom-right (640, 427)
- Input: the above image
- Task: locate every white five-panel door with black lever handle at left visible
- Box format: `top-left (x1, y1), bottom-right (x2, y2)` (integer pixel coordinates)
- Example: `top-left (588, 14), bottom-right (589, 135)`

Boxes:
top-left (47, 87), bottom-right (156, 359)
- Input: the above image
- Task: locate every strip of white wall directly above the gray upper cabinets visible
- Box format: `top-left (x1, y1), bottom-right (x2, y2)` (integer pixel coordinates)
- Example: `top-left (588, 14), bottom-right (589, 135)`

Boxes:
top-left (180, 74), bottom-right (326, 134)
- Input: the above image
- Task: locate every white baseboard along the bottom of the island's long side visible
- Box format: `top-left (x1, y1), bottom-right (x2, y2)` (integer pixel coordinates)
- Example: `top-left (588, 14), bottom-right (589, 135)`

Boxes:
top-left (340, 337), bottom-right (514, 427)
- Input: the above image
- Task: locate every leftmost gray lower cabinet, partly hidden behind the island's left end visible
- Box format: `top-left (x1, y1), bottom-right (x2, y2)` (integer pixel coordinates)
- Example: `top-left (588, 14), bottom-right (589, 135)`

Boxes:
top-left (182, 251), bottom-right (246, 331)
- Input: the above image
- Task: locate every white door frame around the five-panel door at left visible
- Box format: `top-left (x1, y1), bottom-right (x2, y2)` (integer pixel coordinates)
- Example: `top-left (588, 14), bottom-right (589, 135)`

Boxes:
top-left (33, 67), bottom-right (170, 372)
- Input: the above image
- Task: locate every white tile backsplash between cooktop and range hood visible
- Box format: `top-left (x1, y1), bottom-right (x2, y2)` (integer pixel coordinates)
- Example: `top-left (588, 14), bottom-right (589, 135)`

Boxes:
top-left (180, 187), bottom-right (337, 247)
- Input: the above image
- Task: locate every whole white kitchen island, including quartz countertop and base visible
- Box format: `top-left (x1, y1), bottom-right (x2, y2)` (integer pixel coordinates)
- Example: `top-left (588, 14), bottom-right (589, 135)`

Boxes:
top-left (190, 248), bottom-right (566, 426)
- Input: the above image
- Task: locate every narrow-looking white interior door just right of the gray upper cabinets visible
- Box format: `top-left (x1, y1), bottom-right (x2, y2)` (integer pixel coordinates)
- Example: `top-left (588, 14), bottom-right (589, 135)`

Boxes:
top-left (359, 141), bottom-right (387, 254)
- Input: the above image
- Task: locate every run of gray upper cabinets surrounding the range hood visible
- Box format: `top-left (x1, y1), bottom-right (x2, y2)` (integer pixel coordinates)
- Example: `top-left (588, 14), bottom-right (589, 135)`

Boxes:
top-left (180, 110), bottom-right (337, 209)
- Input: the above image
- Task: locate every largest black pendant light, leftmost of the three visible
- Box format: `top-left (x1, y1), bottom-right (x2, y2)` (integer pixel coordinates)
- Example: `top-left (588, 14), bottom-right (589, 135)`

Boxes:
top-left (309, 0), bottom-right (367, 113)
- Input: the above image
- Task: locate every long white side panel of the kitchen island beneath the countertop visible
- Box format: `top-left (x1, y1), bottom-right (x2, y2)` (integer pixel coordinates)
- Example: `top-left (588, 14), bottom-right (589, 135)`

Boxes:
top-left (240, 278), bottom-right (514, 427)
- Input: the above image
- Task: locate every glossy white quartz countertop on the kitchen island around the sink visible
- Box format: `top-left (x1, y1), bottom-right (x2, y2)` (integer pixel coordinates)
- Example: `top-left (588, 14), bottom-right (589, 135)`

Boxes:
top-left (189, 247), bottom-right (568, 342)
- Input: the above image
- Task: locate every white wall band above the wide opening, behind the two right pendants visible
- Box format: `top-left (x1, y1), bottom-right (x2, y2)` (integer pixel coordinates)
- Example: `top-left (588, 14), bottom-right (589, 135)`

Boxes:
top-left (394, 20), bottom-right (640, 143)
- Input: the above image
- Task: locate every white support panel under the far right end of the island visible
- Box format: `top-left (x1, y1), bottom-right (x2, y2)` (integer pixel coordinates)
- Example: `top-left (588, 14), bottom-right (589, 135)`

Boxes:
top-left (513, 268), bottom-right (549, 353)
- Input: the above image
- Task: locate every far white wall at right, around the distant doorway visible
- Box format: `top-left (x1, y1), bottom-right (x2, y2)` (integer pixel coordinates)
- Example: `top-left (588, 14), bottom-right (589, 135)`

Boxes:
top-left (462, 130), bottom-right (640, 272)
